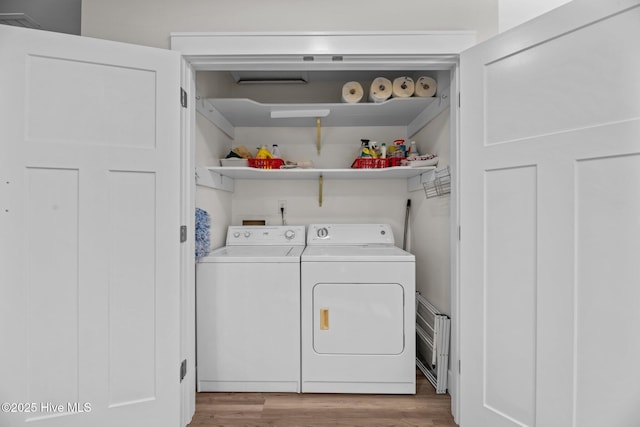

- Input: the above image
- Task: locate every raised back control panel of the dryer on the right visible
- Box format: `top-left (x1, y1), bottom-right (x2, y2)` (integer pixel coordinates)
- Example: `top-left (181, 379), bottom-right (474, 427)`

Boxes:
top-left (307, 224), bottom-right (395, 245)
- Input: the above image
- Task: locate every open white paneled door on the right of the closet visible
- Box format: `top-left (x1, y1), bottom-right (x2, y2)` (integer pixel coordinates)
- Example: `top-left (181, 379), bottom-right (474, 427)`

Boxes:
top-left (459, 0), bottom-right (640, 427)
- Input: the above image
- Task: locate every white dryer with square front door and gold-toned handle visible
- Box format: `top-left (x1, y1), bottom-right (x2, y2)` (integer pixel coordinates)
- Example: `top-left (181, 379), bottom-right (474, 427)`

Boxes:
top-left (301, 224), bottom-right (416, 394)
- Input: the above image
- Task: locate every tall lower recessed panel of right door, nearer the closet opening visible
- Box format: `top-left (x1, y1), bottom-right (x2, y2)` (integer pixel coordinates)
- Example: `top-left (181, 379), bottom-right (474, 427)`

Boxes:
top-left (483, 166), bottom-right (537, 425)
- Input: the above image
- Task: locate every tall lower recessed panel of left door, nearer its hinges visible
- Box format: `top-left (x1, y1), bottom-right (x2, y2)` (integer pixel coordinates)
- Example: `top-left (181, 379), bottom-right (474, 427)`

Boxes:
top-left (108, 171), bottom-right (158, 406)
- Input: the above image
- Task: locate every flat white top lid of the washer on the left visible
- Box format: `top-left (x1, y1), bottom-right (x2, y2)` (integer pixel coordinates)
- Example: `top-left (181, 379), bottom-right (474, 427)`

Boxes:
top-left (199, 246), bottom-right (304, 263)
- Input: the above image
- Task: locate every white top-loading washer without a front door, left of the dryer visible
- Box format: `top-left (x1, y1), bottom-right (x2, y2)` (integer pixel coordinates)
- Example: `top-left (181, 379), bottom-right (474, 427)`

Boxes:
top-left (196, 226), bottom-right (305, 392)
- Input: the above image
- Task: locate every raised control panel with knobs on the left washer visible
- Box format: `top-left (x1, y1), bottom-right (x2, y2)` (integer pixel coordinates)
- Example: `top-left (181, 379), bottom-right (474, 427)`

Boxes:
top-left (227, 225), bottom-right (305, 246)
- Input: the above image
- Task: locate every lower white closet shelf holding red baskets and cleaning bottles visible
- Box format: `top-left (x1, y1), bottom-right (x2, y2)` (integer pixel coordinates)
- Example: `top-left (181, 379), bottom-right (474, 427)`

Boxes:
top-left (196, 166), bottom-right (435, 191)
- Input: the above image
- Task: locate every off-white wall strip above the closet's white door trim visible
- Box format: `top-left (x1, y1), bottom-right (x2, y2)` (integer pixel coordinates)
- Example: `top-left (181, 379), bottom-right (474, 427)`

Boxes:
top-left (82, 0), bottom-right (498, 48)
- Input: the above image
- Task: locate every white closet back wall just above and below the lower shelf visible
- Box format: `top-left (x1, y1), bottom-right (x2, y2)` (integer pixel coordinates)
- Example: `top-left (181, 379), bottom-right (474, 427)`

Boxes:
top-left (232, 126), bottom-right (407, 241)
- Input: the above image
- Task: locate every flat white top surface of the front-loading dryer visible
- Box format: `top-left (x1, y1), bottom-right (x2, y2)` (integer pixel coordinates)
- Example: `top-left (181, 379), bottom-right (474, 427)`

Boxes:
top-left (301, 245), bottom-right (416, 262)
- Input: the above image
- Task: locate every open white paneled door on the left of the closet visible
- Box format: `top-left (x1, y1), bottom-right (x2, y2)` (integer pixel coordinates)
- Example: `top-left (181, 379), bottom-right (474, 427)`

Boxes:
top-left (0, 26), bottom-right (180, 427)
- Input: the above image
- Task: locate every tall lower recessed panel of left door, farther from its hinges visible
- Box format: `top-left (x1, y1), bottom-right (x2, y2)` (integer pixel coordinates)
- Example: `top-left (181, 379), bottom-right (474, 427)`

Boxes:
top-left (24, 168), bottom-right (80, 414)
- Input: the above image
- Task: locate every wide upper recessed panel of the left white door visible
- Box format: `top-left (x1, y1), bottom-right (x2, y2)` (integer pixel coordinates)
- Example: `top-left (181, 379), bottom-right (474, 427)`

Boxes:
top-left (26, 55), bottom-right (157, 148)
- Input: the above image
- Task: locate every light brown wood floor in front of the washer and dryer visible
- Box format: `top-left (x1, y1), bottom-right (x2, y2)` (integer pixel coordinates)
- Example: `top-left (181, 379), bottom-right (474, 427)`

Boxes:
top-left (189, 371), bottom-right (456, 427)
